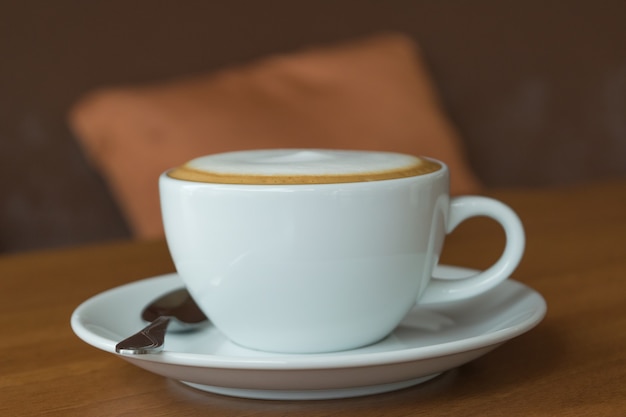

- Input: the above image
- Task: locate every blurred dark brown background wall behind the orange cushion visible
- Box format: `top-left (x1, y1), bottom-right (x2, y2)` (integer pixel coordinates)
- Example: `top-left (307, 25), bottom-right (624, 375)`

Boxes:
top-left (0, 0), bottom-right (626, 254)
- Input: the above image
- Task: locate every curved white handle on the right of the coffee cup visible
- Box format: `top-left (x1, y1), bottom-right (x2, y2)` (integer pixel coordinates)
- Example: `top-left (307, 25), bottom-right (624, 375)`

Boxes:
top-left (419, 196), bottom-right (526, 304)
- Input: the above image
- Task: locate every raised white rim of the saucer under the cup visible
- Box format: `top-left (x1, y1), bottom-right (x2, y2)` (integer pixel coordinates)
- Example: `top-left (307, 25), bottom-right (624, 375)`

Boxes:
top-left (71, 265), bottom-right (547, 371)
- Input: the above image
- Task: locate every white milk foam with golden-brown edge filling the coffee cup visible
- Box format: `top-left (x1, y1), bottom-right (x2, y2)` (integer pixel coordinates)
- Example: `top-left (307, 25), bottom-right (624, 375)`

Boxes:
top-left (168, 149), bottom-right (441, 184)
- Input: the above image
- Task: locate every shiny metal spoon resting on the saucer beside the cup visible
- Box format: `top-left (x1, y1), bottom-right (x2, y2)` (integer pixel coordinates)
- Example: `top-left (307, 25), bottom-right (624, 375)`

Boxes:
top-left (115, 288), bottom-right (208, 355)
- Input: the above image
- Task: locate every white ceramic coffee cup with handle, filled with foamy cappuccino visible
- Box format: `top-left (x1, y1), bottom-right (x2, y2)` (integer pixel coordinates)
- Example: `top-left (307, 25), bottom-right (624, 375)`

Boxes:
top-left (160, 149), bottom-right (525, 353)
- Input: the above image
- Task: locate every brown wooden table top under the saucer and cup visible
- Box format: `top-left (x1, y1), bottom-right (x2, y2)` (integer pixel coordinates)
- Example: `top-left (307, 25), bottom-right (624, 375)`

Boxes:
top-left (0, 181), bottom-right (626, 417)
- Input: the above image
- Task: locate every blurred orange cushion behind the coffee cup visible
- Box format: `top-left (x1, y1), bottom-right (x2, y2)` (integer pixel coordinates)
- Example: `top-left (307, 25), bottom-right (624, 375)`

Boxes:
top-left (69, 34), bottom-right (480, 238)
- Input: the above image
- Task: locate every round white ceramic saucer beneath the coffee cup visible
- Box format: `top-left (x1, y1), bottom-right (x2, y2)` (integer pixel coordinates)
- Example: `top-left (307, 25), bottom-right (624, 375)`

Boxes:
top-left (71, 266), bottom-right (546, 400)
